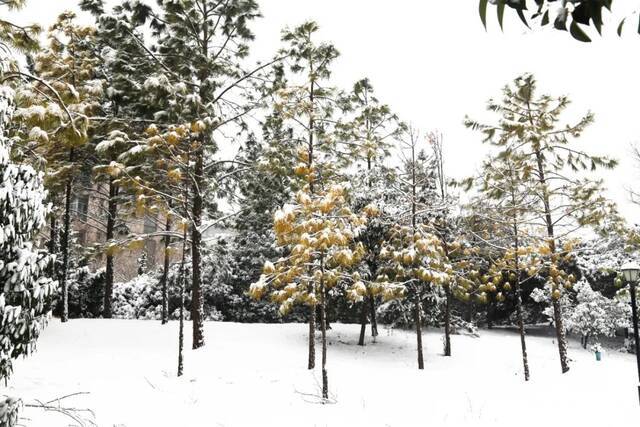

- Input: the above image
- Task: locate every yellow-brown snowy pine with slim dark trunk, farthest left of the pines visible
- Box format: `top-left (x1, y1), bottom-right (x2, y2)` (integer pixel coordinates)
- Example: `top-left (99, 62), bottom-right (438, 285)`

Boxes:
top-left (16, 12), bottom-right (101, 322)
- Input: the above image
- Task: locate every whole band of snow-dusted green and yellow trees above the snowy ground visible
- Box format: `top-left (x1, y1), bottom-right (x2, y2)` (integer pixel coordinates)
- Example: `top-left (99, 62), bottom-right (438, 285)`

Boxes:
top-left (0, 0), bottom-right (638, 425)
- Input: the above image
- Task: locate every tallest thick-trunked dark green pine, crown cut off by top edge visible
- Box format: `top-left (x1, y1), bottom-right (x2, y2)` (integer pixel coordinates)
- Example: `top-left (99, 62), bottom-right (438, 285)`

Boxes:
top-left (105, 0), bottom-right (273, 349)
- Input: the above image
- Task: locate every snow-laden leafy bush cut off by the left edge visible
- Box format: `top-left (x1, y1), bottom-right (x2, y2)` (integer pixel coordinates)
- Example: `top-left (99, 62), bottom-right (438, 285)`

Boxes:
top-left (0, 86), bottom-right (57, 380)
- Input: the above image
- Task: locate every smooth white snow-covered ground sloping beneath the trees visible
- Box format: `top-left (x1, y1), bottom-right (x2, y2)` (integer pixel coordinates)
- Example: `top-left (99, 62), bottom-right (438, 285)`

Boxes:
top-left (9, 319), bottom-right (640, 427)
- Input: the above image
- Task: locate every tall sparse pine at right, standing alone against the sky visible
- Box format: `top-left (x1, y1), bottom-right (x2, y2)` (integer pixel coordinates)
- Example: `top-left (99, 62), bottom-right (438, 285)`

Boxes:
top-left (465, 75), bottom-right (616, 373)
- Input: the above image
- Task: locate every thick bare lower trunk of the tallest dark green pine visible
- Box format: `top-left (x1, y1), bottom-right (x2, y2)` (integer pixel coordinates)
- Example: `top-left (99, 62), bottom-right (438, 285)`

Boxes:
top-left (191, 147), bottom-right (204, 350)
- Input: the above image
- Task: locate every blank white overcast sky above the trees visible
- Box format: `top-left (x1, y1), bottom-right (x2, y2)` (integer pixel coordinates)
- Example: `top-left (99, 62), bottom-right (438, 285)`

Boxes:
top-left (8, 0), bottom-right (640, 223)
